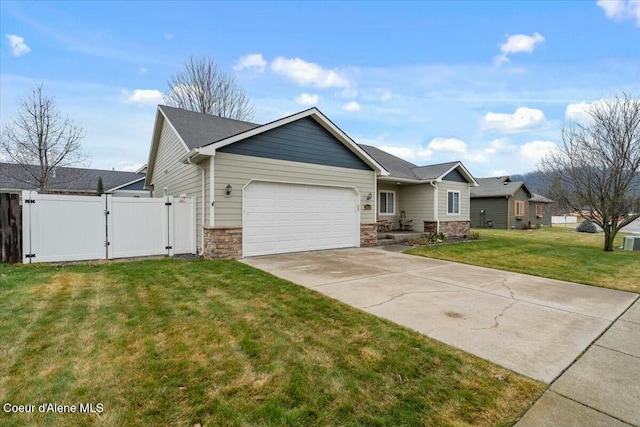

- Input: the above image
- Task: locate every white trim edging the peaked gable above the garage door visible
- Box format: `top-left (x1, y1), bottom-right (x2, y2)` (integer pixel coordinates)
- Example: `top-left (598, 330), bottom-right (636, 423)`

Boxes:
top-left (196, 107), bottom-right (389, 176)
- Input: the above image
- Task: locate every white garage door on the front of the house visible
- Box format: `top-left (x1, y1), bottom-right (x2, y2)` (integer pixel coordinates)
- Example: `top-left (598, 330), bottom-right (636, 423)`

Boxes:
top-left (242, 181), bottom-right (360, 256)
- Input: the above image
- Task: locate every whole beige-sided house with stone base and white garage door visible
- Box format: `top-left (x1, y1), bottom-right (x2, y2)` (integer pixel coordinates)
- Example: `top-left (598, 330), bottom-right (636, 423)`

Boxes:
top-left (145, 105), bottom-right (475, 259)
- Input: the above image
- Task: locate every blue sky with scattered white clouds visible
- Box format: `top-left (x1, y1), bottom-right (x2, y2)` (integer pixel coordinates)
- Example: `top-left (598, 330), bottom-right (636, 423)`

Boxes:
top-left (0, 0), bottom-right (640, 177)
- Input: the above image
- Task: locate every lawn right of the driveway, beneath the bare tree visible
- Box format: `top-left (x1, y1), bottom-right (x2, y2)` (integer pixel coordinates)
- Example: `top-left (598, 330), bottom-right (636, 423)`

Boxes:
top-left (407, 227), bottom-right (640, 293)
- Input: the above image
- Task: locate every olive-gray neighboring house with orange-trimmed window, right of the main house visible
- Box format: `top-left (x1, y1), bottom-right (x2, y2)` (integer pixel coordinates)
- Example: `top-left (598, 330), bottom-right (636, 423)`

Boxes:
top-left (471, 176), bottom-right (553, 229)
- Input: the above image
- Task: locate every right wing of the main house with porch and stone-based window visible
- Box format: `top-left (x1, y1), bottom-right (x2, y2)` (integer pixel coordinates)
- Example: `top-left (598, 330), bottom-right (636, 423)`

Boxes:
top-left (361, 145), bottom-right (477, 237)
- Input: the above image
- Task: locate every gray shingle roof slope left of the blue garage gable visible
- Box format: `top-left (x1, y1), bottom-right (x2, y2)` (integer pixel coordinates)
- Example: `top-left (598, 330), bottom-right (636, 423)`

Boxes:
top-left (158, 105), bottom-right (260, 149)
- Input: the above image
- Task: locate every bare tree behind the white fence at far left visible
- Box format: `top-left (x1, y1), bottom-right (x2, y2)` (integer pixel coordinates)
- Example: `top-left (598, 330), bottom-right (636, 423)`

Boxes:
top-left (0, 83), bottom-right (87, 193)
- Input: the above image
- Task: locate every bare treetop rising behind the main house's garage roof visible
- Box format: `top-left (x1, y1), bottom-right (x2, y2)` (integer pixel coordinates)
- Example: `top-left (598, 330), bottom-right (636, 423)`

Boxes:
top-left (164, 56), bottom-right (255, 120)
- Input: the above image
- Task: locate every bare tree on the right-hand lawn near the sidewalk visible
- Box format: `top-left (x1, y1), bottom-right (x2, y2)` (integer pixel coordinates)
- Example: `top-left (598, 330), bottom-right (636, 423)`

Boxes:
top-left (542, 94), bottom-right (640, 251)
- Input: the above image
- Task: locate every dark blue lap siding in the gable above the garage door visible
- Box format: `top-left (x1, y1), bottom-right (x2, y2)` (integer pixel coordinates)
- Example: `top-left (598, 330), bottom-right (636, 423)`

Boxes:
top-left (218, 117), bottom-right (371, 170)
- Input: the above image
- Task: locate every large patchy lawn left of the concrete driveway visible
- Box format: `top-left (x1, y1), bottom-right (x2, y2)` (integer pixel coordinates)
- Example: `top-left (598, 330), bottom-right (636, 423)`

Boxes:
top-left (0, 260), bottom-right (545, 426)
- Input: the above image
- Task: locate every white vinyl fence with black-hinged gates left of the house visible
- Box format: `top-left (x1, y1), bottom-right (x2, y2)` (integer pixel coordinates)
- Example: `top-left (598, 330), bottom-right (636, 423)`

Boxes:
top-left (22, 191), bottom-right (196, 263)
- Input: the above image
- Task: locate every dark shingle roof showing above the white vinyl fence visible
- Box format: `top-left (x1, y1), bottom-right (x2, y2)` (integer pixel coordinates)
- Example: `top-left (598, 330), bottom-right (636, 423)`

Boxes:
top-left (0, 163), bottom-right (145, 192)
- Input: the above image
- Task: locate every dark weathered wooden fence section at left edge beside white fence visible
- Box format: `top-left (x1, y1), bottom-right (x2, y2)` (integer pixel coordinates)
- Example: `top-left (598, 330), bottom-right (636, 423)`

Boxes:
top-left (0, 193), bottom-right (22, 263)
